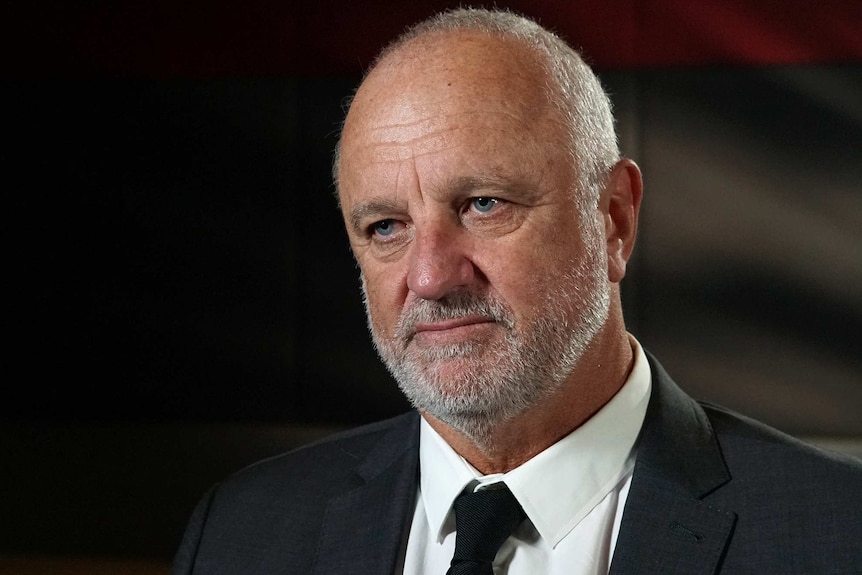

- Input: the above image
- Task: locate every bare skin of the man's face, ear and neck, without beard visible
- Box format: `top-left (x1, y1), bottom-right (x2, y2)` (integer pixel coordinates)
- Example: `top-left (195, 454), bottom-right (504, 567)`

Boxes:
top-left (337, 31), bottom-right (641, 473)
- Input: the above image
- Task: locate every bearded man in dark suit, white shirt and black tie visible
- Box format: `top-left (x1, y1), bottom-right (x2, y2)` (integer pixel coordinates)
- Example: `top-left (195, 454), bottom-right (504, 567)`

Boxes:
top-left (175, 6), bottom-right (862, 575)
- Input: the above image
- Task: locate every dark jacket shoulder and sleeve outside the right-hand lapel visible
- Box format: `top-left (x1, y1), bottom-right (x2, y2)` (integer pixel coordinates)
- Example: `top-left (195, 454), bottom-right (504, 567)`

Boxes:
top-left (703, 404), bottom-right (862, 573)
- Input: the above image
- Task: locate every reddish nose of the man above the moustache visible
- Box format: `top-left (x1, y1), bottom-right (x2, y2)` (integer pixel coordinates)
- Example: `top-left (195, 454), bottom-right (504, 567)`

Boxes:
top-left (407, 225), bottom-right (477, 300)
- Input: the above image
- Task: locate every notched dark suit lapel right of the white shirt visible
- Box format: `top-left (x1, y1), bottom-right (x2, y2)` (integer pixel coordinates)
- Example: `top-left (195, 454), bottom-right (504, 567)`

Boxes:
top-left (610, 356), bottom-right (736, 575)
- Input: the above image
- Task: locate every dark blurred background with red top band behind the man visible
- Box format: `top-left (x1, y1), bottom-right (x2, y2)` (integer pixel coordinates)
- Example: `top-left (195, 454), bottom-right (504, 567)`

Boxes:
top-left (0, 0), bottom-right (862, 574)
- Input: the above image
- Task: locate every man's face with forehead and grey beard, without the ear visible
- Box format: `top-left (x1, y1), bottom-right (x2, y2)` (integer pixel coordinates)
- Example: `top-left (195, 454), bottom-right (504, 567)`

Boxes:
top-left (339, 33), bottom-right (609, 435)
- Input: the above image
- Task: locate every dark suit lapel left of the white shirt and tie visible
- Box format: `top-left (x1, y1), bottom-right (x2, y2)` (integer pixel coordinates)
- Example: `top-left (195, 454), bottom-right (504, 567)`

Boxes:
top-left (314, 415), bottom-right (419, 575)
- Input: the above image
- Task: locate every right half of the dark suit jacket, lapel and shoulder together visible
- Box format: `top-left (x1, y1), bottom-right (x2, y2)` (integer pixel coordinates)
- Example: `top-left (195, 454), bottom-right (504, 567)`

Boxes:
top-left (636, 354), bottom-right (862, 574)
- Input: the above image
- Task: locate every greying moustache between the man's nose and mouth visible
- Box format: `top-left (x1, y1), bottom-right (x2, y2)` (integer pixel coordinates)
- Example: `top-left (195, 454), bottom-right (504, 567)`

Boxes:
top-left (395, 292), bottom-right (515, 339)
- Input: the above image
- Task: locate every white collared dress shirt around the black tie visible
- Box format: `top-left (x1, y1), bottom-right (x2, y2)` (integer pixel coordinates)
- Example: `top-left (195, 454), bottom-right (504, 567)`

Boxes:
top-left (403, 336), bottom-right (651, 575)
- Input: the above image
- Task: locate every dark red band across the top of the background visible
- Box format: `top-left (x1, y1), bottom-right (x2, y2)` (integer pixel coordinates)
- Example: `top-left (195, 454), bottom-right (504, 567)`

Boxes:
top-left (0, 0), bottom-right (862, 77)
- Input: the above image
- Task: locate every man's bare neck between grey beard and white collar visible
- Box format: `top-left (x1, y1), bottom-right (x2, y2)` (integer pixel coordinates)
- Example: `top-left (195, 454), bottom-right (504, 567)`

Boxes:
top-left (422, 313), bottom-right (634, 475)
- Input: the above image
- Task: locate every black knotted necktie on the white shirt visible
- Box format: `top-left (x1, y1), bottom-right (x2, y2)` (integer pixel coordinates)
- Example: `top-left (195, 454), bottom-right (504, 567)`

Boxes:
top-left (446, 483), bottom-right (526, 575)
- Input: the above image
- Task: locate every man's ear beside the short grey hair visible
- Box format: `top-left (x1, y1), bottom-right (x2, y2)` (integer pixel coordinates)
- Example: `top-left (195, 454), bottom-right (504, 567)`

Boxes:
top-left (599, 158), bottom-right (643, 283)
